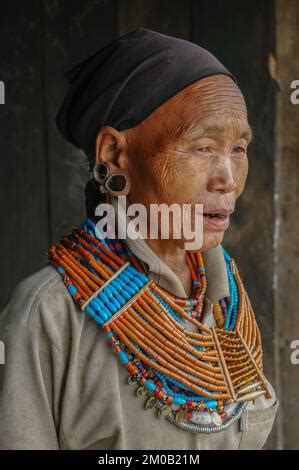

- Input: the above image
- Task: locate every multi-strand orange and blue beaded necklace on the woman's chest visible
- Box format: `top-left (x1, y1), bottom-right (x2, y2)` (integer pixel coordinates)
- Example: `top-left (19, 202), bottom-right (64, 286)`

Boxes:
top-left (49, 219), bottom-right (271, 433)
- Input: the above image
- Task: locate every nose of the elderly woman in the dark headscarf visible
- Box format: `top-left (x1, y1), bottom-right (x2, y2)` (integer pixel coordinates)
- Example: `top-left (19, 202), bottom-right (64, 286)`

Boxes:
top-left (208, 157), bottom-right (237, 193)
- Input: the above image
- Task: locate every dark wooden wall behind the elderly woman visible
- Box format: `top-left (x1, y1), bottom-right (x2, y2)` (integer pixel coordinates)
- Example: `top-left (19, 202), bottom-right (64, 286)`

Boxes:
top-left (0, 0), bottom-right (299, 449)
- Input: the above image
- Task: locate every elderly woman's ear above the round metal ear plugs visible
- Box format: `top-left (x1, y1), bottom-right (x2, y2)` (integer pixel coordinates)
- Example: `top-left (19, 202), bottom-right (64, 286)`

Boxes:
top-left (95, 126), bottom-right (129, 173)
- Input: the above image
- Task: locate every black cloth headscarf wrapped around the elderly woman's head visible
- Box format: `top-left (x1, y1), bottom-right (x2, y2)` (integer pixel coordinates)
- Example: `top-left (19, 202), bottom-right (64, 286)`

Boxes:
top-left (56, 28), bottom-right (236, 159)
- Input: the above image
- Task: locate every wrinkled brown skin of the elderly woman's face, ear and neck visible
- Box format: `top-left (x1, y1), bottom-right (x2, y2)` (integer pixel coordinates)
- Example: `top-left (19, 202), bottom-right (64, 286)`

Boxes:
top-left (96, 75), bottom-right (251, 295)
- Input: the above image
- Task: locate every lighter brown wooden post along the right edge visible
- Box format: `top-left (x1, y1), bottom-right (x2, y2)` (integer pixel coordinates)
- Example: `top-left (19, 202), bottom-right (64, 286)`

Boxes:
top-left (274, 0), bottom-right (299, 449)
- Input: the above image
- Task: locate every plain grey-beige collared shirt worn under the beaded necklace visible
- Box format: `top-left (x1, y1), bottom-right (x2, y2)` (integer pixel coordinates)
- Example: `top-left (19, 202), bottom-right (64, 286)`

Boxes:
top-left (0, 229), bottom-right (278, 450)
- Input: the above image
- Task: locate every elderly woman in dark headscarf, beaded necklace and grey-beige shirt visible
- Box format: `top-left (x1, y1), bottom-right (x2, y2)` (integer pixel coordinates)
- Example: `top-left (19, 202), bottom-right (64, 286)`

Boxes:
top-left (0, 28), bottom-right (278, 449)
